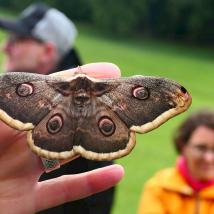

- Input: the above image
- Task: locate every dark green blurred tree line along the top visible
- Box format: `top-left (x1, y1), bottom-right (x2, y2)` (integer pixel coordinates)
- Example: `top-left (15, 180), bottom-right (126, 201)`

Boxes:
top-left (0, 0), bottom-right (214, 44)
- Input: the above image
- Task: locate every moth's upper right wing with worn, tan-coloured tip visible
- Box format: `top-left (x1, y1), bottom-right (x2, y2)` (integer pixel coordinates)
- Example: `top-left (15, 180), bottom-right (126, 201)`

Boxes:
top-left (99, 76), bottom-right (191, 133)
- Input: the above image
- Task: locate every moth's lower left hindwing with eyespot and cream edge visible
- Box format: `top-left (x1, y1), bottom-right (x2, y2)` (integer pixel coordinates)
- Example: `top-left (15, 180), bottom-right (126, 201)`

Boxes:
top-left (28, 97), bottom-right (77, 159)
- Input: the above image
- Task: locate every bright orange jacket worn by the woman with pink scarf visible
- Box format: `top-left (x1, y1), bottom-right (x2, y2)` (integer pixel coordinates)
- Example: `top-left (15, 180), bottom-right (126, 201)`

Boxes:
top-left (138, 168), bottom-right (214, 214)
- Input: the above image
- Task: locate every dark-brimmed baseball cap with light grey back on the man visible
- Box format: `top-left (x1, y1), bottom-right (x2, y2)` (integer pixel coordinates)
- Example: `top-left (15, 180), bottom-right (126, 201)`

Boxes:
top-left (0, 3), bottom-right (77, 55)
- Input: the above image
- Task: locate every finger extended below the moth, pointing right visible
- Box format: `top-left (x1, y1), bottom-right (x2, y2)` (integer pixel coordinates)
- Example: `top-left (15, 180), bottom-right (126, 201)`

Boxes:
top-left (36, 165), bottom-right (124, 211)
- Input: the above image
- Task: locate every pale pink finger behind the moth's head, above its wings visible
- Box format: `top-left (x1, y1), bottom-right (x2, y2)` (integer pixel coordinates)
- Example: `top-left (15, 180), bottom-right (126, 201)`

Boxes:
top-left (51, 62), bottom-right (121, 78)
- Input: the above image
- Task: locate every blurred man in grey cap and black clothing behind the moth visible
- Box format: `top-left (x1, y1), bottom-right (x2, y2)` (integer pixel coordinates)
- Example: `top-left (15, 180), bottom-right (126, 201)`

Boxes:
top-left (0, 3), bottom-right (114, 214)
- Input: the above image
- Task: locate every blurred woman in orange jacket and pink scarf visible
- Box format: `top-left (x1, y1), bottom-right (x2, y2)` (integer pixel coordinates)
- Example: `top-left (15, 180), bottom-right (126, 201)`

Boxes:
top-left (138, 110), bottom-right (214, 214)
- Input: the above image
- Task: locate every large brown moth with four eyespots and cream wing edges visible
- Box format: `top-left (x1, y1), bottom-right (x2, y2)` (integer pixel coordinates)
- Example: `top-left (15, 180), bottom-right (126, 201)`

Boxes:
top-left (0, 73), bottom-right (191, 160)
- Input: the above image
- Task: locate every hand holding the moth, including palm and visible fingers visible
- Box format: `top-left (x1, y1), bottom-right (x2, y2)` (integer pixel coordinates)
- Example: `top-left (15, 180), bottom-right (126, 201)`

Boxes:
top-left (0, 63), bottom-right (124, 214)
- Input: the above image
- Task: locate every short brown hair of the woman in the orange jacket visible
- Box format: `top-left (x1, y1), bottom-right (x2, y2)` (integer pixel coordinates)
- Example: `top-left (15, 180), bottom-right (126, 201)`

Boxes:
top-left (174, 110), bottom-right (214, 153)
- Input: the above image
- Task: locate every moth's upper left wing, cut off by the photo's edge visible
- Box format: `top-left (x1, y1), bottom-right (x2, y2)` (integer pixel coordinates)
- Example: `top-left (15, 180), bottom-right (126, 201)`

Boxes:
top-left (0, 72), bottom-right (67, 130)
